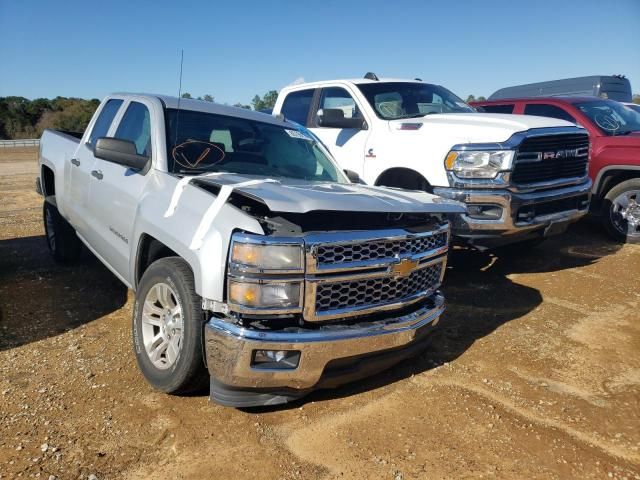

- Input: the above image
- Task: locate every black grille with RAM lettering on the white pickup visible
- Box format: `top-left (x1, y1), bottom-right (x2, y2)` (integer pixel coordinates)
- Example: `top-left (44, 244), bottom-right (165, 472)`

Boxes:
top-left (511, 133), bottom-right (589, 185)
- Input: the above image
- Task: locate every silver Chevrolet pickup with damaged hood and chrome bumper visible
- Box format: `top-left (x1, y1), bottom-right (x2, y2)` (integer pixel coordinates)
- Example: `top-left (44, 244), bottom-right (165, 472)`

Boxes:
top-left (37, 94), bottom-right (464, 407)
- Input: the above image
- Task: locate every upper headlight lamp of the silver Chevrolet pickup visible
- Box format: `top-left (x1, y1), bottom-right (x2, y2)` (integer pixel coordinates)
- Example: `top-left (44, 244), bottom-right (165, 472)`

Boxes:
top-left (231, 240), bottom-right (302, 270)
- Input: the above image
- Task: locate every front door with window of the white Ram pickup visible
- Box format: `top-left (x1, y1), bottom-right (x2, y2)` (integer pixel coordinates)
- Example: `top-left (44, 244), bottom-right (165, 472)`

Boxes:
top-left (309, 87), bottom-right (370, 177)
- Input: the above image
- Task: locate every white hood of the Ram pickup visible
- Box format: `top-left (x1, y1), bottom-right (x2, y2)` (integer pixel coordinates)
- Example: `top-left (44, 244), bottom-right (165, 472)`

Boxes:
top-left (389, 113), bottom-right (582, 143)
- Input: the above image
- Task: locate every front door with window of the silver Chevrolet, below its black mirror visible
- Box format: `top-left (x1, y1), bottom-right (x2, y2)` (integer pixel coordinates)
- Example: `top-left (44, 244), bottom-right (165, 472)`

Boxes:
top-left (88, 100), bottom-right (153, 281)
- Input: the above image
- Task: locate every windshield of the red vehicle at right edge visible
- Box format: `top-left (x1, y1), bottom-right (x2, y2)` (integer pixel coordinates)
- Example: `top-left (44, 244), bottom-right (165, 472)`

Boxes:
top-left (575, 100), bottom-right (640, 135)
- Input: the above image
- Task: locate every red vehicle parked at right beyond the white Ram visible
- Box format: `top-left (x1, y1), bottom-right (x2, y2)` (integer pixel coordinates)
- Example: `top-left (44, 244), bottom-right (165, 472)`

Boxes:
top-left (471, 97), bottom-right (640, 243)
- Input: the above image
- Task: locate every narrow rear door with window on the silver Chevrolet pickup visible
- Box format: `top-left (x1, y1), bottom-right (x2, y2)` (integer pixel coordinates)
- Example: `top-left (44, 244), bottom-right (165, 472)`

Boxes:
top-left (64, 99), bottom-right (123, 235)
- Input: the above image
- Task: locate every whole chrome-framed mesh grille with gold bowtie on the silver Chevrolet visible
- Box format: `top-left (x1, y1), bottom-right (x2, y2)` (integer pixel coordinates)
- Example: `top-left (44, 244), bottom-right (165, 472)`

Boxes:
top-left (304, 223), bottom-right (449, 322)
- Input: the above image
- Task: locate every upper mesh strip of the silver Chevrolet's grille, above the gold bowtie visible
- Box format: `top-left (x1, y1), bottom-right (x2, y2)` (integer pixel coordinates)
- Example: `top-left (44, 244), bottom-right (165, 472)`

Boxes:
top-left (316, 232), bottom-right (447, 265)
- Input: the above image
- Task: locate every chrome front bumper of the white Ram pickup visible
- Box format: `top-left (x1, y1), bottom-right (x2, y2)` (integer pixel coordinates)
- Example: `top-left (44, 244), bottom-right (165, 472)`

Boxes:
top-left (434, 179), bottom-right (592, 240)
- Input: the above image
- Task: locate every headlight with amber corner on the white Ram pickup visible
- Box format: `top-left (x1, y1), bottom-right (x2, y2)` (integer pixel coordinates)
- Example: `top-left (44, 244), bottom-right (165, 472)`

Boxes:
top-left (444, 150), bottom-right (514, 178)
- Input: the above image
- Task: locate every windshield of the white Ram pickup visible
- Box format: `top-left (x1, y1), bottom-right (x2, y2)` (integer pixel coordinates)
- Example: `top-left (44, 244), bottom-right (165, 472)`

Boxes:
top-left (358, 82), bottom-right (475, 120)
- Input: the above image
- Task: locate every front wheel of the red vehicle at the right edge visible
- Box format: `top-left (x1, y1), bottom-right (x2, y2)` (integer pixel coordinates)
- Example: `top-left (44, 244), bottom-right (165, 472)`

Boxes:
top-left (602, 178), bottom-right (640, 243)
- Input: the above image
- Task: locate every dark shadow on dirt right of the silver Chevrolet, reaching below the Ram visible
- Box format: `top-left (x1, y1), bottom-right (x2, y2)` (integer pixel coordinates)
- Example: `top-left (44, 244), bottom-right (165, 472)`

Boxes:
top-left (247, 219), bottom-right (621, 413)
